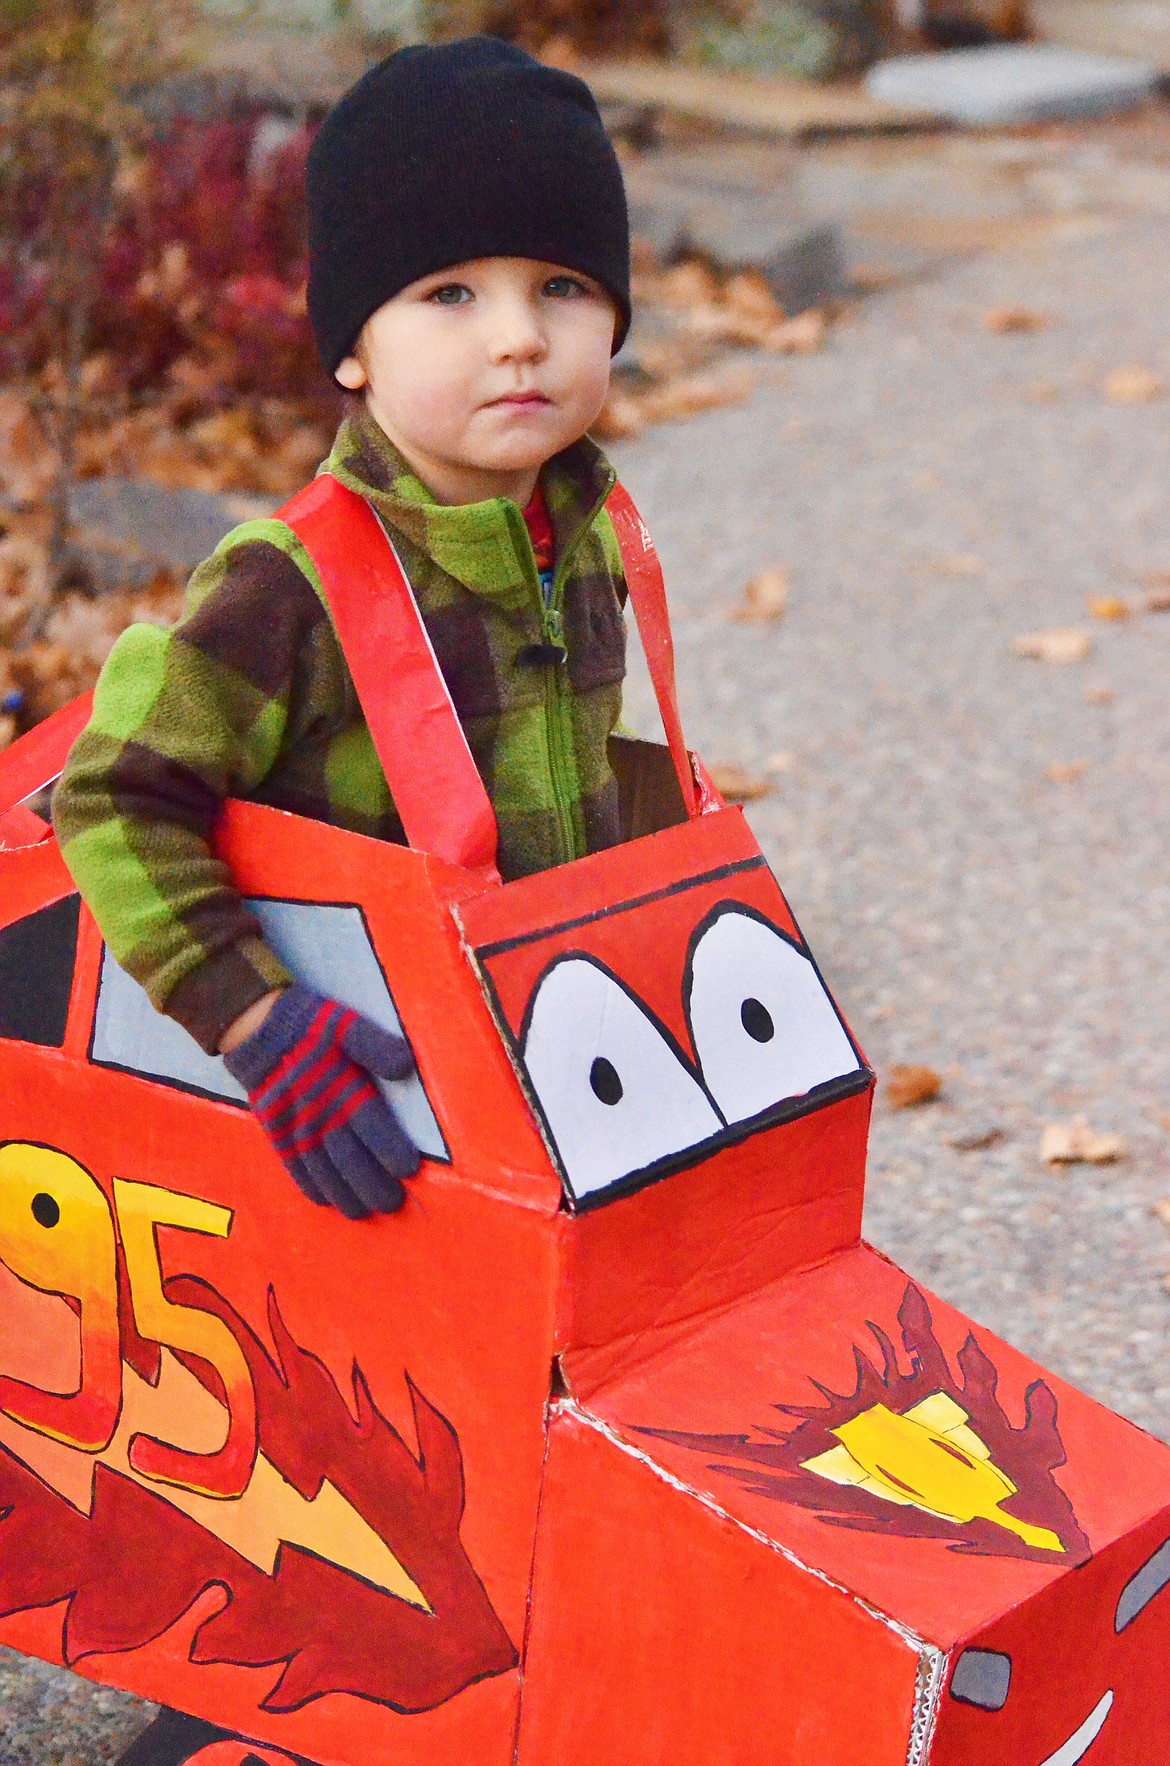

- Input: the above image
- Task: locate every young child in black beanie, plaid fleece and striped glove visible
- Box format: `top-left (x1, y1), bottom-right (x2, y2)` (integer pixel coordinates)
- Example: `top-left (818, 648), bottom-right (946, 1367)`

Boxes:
top-left (53, 37), bottom-right (630, 1219)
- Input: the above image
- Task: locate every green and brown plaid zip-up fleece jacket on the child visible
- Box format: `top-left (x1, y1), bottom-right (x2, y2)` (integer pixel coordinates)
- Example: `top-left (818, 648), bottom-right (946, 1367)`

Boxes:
top-left (53, 413), bottom-right (625, 1051)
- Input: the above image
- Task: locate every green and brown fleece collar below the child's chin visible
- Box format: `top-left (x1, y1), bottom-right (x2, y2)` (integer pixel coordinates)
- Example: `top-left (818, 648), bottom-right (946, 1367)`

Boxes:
top-left (323, 410), bottom-right (616, 599)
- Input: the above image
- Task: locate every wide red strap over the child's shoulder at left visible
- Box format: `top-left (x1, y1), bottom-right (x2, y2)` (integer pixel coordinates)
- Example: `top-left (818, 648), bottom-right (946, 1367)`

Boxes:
top-left (279, 473), bottom-right (499, 881)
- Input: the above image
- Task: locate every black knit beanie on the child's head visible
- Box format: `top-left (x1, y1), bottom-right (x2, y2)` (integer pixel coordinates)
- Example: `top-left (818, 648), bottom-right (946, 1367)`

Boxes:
top-left (309, 37), bottom-right (630, 374)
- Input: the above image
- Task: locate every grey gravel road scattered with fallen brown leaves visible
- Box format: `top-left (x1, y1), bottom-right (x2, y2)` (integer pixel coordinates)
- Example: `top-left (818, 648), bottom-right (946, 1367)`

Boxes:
top-left (0, 117), bottom-right (1170, 1766)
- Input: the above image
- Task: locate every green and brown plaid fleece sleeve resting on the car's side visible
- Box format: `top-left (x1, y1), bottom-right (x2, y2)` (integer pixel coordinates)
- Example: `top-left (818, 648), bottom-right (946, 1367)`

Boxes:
top-left (53, 521), bottom-right (326, 1053)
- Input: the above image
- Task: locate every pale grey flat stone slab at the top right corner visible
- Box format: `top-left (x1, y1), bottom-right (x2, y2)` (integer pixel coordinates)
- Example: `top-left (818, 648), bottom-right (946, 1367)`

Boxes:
top-left (865, 42), bottom-right (1159, 127)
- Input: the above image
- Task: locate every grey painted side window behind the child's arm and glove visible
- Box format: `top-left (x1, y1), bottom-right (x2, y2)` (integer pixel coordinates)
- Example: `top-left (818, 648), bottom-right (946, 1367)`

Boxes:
top-left (90, 897), bottom-right (450, 1160)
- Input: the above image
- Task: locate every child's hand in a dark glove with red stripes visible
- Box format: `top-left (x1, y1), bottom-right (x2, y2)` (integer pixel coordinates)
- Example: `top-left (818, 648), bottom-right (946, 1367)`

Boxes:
top-left (224, 982), bottom-right (420, 1220)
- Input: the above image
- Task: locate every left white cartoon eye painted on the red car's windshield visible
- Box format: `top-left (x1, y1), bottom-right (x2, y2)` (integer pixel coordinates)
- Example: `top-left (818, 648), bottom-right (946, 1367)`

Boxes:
top-left (522, 957), bottom-right (724, 1199)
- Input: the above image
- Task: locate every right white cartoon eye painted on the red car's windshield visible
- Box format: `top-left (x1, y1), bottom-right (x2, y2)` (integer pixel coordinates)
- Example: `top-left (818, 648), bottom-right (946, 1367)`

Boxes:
top-left (686, 908), bottom-right (861, 1121)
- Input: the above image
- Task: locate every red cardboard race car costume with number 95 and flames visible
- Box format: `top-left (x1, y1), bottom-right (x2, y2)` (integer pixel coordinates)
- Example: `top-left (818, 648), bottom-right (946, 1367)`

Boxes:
top-left (0, 480), bottom-right (1170, 1766)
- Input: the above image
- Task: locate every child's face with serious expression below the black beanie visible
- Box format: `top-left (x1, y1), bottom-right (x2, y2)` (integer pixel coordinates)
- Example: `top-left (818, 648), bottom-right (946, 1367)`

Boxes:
top-left (337, 258), bottom-right (616, 503)
